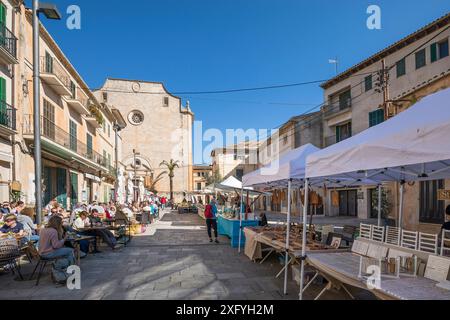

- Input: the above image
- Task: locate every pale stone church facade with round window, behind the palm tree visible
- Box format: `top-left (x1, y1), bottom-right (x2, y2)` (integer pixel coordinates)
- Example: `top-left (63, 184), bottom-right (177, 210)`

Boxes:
top-left (94, 78), bottom-right (194, 202)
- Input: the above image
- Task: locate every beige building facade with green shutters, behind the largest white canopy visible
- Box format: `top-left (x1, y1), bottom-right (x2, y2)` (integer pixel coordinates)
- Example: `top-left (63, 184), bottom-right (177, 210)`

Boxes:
top-left (322, 14), bottom-right (450, 232)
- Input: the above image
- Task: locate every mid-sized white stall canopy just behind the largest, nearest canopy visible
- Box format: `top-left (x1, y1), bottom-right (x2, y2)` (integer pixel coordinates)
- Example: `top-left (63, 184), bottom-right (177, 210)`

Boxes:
top-left (242, 144), bottom-right (320, 187)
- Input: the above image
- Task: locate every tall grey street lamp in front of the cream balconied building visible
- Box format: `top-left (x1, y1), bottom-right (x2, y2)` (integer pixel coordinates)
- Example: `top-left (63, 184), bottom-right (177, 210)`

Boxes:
top-left (32, 0), bottom-right (61, 224)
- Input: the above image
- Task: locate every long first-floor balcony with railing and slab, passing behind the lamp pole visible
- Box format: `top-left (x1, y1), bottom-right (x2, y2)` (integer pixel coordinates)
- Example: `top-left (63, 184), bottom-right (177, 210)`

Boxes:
top-left (23, 115), bottom-right (109, 171)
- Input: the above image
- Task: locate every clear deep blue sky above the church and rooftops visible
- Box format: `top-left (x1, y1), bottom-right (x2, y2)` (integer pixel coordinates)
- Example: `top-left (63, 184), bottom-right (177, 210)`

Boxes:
top-left (33, 0), bottom-right (450, 163)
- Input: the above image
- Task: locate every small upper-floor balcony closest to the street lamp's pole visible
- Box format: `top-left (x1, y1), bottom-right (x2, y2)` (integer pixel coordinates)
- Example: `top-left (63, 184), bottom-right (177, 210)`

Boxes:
top-left (40, 57), bottom-right (72, 96)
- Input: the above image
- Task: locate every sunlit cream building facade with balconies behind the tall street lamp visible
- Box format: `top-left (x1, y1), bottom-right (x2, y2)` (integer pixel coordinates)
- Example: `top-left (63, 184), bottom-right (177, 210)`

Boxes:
top-left (5, 1), bottom-right (125, 209)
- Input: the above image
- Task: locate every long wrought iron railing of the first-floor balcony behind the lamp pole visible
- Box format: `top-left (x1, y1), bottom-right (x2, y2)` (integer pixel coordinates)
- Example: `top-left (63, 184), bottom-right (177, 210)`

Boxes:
top-left (23, 115), bottom-right (108, 168)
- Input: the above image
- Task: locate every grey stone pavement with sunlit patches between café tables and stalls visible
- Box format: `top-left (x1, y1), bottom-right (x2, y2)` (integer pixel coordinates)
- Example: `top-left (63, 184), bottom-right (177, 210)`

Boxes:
top-left (0, 212), bottom-right (370, 300)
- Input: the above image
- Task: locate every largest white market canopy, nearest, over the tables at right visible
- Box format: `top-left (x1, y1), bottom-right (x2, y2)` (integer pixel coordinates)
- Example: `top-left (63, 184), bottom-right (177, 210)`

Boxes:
top-left (306, 89), bottom-right (450, 184)
